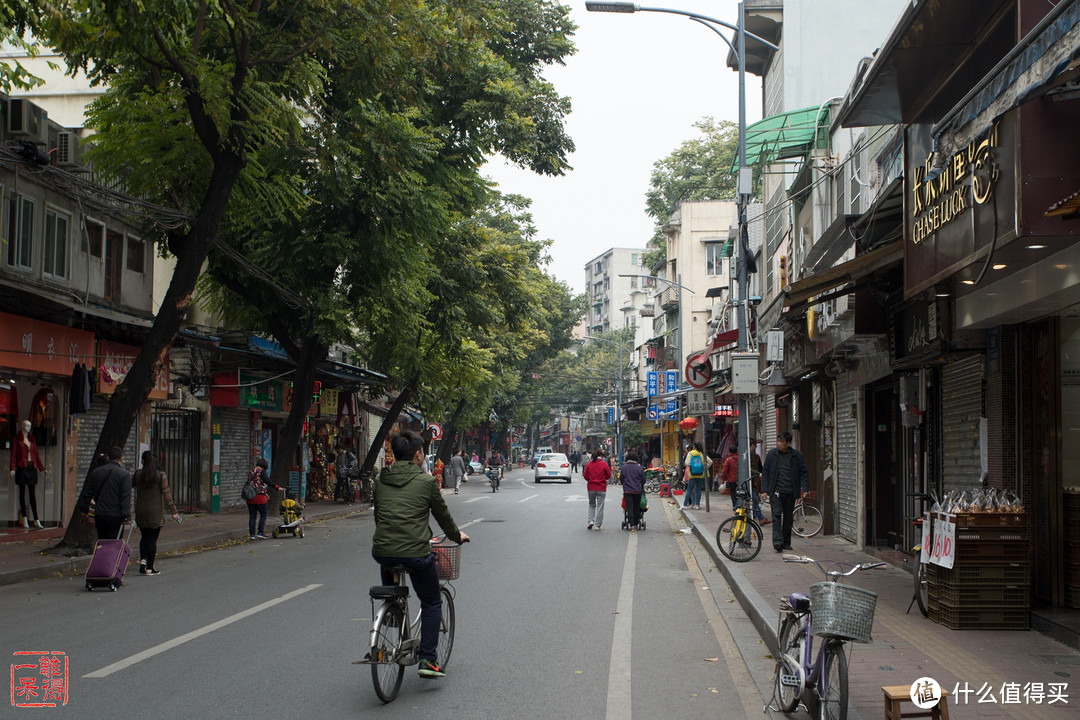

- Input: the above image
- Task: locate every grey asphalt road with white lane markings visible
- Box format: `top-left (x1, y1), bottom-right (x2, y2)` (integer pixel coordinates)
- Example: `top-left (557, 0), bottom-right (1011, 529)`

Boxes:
top-left (0, 470), bottom-right (761, 720)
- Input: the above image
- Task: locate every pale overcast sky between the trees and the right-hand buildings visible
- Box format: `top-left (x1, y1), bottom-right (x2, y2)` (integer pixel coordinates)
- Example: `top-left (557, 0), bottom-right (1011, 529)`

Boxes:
top-left (486, 0), bottom-right (761, 293)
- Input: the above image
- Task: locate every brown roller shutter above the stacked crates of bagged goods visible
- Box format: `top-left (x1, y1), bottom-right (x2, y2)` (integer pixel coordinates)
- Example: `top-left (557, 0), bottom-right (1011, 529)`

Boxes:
top-left (942, 355), bottom-right (985, 492)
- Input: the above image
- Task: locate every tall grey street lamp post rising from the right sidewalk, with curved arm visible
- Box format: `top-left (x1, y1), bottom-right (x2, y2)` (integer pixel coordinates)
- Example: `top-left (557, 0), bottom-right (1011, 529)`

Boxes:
top-left (585, 2), bottom-right (780, 515)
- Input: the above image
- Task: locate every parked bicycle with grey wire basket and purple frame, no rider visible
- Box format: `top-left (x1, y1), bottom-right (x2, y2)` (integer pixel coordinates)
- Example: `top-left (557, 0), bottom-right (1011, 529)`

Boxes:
top-left (766, 555), bottom-right (886, 720)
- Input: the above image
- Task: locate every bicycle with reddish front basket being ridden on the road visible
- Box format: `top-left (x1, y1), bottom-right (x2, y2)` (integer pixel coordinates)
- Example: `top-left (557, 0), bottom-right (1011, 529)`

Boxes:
top-left (360, 538), bottom-right (461, 703)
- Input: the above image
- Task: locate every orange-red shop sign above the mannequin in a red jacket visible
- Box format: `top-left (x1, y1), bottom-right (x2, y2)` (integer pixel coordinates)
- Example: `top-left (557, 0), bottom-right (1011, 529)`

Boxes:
top-left (0, 313), bottom-right (95, 375)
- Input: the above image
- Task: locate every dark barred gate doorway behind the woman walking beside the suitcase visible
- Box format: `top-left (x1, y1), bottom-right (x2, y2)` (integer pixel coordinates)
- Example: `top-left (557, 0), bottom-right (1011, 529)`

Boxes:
top-left (150, 408), bottom-right (202, 513)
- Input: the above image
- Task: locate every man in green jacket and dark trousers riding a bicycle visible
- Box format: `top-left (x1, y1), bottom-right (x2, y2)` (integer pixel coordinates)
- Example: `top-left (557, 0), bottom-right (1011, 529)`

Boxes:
top-left (372, 430), bottom-right (469, 678)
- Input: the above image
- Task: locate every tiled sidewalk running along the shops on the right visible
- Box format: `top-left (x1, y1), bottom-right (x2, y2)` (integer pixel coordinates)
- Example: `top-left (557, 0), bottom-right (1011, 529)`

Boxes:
top-left (678, 498), bottom-right (1080, 720)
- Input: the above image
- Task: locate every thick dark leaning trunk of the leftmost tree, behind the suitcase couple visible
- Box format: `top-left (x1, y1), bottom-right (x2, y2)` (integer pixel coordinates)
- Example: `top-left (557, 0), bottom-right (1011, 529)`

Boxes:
top-left (54, 154), bottom-right (244, 549)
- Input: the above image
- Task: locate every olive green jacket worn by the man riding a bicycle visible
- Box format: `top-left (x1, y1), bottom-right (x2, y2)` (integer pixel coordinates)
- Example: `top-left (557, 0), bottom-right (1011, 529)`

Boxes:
top-left (372, 460), bottom-right (461, 557)
